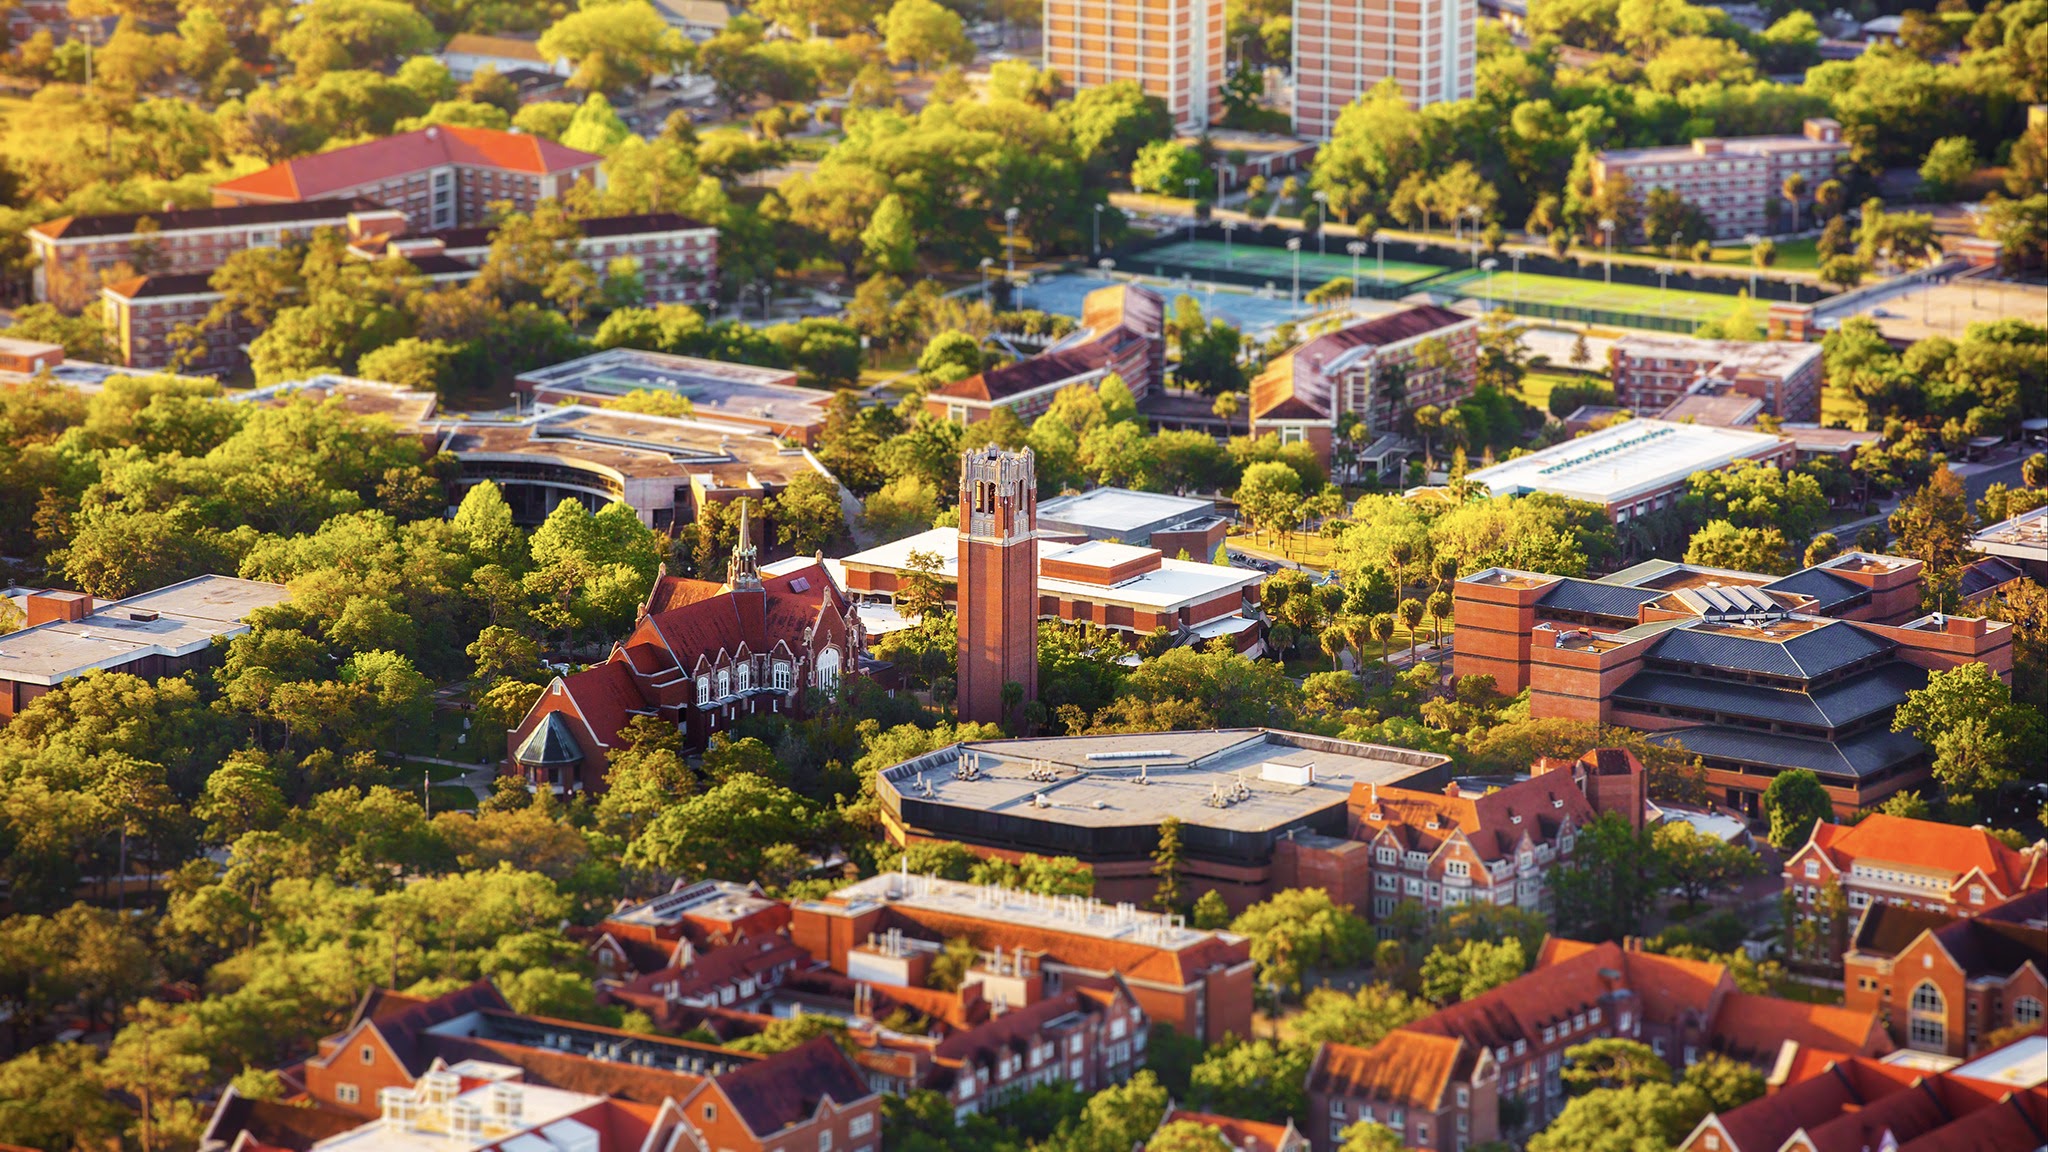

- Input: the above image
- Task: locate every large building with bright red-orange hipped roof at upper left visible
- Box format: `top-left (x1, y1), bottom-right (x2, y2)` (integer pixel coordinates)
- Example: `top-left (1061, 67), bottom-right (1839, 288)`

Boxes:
top-left (213, 125), bottom-right (604, 232)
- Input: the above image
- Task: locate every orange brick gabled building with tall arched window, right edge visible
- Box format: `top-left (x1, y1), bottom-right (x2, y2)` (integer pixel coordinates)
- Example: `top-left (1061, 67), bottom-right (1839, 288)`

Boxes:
top-left (1841, 888), bottom-right (2048, 1058)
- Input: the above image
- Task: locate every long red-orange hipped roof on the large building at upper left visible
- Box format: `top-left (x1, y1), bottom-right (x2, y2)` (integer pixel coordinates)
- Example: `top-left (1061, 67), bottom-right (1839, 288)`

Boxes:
top-left (213, 125), bottom-right (602, 201)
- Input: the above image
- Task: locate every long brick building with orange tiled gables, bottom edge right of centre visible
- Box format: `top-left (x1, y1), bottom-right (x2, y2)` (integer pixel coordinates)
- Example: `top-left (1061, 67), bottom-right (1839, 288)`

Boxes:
top-left (1309, 937), bottom-right (1890, 1152)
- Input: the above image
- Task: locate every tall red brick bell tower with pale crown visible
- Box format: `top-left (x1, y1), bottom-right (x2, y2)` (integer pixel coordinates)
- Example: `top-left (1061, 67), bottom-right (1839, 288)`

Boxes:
top-left (958, 447), bottom-right (1038, 724)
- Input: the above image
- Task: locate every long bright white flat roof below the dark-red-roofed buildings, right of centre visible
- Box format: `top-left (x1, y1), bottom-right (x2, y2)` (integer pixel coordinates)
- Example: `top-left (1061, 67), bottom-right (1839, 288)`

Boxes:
top-left (1468, 412), bottom-right (1784, 504)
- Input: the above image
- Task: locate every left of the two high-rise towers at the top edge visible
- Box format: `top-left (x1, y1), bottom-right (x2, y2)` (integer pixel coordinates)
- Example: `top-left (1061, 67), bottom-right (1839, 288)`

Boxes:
top-left (1042, 0), bottom-right (1227, 131)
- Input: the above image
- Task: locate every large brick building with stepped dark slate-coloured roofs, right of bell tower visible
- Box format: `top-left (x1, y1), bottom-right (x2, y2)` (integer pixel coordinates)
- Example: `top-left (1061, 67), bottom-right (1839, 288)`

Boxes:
top-left (1452, 551), bottom-right (2013, 818)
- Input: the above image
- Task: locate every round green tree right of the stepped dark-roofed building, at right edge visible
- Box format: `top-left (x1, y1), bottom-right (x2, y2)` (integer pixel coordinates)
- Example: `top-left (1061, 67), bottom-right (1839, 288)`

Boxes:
top-left (1892, 664), bottom-right (2048, 806)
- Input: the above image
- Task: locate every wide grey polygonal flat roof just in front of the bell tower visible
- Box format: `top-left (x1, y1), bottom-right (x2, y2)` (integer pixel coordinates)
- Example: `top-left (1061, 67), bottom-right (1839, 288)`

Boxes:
top-left (881, 728), bottom-right (1448, 832)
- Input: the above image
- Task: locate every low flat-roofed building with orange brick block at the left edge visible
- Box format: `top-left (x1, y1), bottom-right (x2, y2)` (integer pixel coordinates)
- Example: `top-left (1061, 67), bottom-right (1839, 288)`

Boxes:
top-left (0, 576), bottom-right (289, 719)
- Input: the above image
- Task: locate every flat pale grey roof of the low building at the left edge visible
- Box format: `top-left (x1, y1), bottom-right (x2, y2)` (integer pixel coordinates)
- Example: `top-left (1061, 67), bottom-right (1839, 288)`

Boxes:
top-left (0, 576), bottom-right (289, 685)
